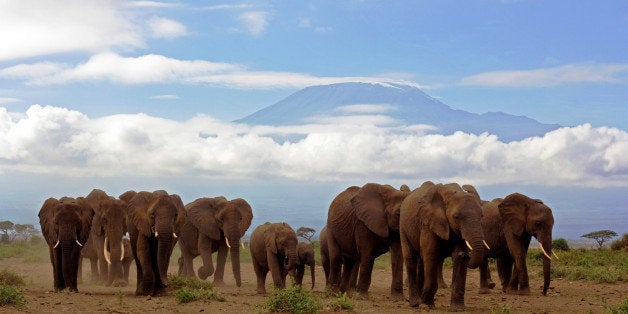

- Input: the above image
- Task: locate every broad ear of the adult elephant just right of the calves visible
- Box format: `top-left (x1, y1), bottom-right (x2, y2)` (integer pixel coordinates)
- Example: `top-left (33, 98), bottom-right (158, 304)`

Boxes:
top-left (351, 183), bottom-right (392, 238)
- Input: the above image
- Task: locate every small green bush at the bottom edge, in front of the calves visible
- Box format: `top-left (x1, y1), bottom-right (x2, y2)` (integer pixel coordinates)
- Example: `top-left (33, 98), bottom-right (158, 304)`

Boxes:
top-left (265, 285), bottom-right (323, 313)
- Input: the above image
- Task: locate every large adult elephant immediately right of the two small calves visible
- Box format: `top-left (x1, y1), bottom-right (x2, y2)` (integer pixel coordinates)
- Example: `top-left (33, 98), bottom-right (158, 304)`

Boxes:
top-left (327, 183), bottom-right (410, 299)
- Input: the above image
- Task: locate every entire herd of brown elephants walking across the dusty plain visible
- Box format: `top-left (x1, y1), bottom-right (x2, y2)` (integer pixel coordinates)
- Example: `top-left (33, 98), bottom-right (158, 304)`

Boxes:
top-left (39, 181), bottom-right (554, 310)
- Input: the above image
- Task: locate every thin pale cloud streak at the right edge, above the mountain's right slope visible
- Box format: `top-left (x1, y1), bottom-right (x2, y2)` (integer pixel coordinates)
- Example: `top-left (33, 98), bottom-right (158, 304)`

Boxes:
top-left (461, 63), bottom-right (628, 87)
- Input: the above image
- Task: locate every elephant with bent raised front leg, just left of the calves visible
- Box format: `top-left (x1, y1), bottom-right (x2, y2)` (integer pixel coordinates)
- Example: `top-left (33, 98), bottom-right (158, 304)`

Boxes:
top-left (179, 196), bottom-right (253, 287)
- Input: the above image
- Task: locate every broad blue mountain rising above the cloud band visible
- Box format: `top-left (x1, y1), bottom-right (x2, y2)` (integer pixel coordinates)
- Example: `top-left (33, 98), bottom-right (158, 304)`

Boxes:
top-left (236, 83), bottom-right (560, 142)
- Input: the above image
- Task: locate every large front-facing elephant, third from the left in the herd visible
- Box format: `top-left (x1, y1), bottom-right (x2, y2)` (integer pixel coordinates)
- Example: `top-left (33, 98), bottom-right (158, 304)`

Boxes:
top-left (127, 190), bottom-right (186, 296)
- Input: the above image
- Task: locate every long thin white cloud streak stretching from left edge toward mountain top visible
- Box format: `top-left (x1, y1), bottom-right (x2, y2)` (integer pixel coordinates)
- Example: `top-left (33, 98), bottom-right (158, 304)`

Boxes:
top-left (0, 52), bottom-right (422, 89)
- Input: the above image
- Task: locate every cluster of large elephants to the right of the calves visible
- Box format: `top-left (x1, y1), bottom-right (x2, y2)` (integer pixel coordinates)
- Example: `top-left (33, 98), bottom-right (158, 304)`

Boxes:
top-left (320, 181), bottom-right (554, 311)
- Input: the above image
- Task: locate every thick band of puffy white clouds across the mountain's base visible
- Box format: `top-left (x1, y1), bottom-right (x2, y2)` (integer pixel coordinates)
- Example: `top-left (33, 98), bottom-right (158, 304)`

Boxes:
top-left (0, 105), bottom-right (628, 187)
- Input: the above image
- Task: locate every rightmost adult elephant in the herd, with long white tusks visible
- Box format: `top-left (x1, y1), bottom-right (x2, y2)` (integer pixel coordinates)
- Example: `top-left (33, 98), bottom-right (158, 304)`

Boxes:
top-left (498, 193), bottom-right (554, 295)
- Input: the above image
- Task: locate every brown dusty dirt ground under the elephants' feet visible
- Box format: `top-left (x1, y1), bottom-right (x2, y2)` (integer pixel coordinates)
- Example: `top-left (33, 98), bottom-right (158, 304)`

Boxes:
top-left (0, 254), bottom-right (628, 313)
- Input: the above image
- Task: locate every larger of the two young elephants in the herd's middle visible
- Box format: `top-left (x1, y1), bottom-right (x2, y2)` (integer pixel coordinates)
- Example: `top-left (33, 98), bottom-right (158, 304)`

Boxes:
top-left (249, 222), bottom-right (299, 294)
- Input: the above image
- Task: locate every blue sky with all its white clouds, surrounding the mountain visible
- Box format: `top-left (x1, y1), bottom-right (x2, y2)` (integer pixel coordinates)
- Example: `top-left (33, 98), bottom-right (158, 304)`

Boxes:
top-left (0, 0), bottom-right (628, 233)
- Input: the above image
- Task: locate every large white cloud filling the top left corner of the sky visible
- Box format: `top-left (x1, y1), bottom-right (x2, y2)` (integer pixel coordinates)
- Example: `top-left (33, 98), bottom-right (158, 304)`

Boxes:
top-left (0, 0), bottom-right (144, 61)
